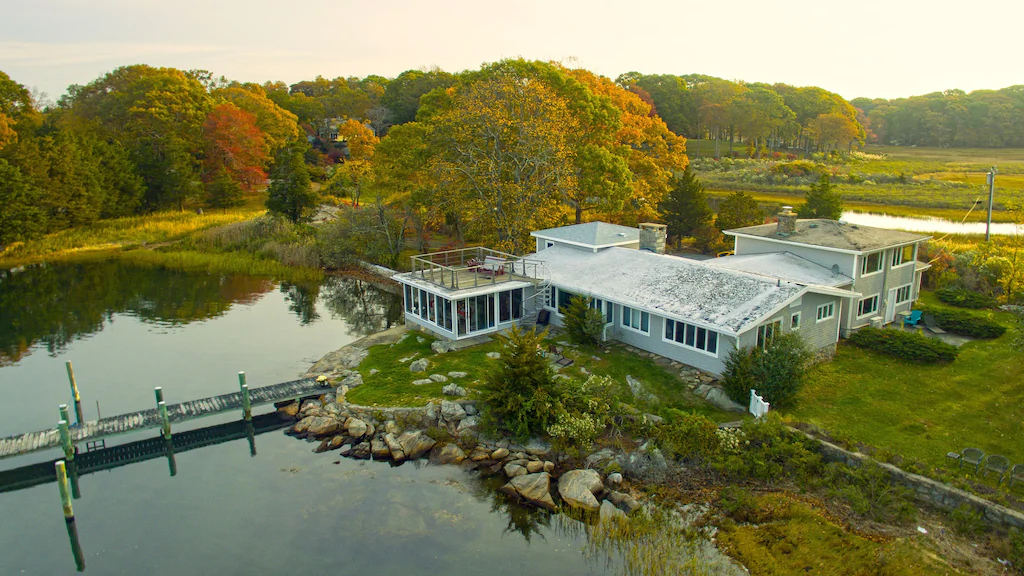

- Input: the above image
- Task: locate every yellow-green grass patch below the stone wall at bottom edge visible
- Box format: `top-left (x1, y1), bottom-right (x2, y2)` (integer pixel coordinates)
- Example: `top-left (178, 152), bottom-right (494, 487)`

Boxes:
top-left (718, 487), bottom-right (962, 576)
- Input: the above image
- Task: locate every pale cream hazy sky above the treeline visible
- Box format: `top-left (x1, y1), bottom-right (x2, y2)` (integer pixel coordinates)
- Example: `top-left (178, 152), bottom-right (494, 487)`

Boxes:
top-left (0, 0), bottom-right (1024, 99)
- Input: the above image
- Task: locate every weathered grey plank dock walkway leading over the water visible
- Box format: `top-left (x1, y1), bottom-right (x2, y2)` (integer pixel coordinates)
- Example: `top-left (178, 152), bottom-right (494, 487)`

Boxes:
top-left (0, 378), bottom-right (328, 458)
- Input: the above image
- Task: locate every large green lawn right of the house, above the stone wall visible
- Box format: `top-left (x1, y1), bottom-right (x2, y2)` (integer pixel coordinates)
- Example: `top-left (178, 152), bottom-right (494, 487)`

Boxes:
top-left (786, 292), bottom-right (1024, 491)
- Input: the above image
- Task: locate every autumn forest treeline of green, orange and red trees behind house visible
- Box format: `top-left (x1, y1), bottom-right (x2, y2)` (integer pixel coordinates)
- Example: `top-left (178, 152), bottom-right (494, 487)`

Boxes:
top-left (0, 59), bottom-right (1024, 249)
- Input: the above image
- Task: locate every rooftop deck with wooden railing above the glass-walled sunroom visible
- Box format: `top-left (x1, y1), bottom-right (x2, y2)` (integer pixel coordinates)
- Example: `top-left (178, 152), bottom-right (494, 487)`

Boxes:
top-left (412, 247), bottom-right (544, 290)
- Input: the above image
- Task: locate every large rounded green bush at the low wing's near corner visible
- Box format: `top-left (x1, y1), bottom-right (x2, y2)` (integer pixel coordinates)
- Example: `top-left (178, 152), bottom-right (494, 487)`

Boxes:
top-left (723, 332), bottom-right (811, 406)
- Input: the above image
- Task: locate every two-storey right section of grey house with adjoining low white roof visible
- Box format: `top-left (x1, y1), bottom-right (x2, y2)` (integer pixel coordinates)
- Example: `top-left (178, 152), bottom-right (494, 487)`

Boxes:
top-left (724, 206), bottom-right (931, 336)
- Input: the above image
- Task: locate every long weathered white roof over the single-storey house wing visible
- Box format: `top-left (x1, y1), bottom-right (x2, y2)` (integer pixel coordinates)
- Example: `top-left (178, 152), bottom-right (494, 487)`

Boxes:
top-left (529, 246), bottom-right (807, 334)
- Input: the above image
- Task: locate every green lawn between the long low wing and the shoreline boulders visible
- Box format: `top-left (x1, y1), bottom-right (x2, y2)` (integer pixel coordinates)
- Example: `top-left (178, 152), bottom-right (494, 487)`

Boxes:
top-left (348, 332), bottom-right (740, 422)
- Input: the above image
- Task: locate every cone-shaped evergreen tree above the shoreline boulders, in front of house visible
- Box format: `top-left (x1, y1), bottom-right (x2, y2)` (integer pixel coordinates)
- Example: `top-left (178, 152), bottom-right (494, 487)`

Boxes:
top-left (480, 326), bottom-right (561, 441)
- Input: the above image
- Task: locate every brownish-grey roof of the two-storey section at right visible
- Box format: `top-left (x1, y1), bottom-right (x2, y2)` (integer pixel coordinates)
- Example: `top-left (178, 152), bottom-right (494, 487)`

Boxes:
top-left (725, 218), bottom-right (931, 253)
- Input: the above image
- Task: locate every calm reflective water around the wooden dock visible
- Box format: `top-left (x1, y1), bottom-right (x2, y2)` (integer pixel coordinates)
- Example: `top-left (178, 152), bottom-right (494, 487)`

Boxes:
top-left (0, 263), bottom-right (608, 575)
